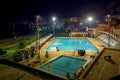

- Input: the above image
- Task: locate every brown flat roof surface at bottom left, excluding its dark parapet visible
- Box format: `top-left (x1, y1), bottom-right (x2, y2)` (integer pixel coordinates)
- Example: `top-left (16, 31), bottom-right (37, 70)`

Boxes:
top-left (0, 64), bottom-right (40, 80)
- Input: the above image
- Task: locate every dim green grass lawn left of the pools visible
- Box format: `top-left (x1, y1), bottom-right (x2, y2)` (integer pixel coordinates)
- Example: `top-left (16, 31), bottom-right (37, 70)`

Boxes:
top-left (0, 34), bottom-right (35, 59)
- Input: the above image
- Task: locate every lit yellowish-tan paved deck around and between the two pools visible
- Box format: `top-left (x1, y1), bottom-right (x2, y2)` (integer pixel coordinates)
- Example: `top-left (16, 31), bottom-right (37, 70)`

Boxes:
top-left (20, 38), bottom-right (103, 66)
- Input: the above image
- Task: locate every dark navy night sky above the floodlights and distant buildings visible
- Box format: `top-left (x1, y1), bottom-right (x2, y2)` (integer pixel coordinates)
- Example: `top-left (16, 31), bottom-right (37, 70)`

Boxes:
top-left (0, 0), bottom-right (109, 23)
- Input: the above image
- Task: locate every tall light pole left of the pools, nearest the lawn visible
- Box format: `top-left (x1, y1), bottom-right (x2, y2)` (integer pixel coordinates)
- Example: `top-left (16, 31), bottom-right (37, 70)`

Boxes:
top-left (36, 15), bottom-right (40, 61)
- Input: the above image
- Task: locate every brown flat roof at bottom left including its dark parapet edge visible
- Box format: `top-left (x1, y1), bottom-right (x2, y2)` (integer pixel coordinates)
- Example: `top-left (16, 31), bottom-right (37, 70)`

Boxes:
top-left (0, 59), bottom-right (65, 80)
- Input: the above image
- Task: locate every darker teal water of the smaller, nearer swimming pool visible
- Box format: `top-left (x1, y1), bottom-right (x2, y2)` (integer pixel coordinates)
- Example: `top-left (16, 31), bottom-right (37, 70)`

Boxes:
top-left (38, 55), bottom-right (87, 78)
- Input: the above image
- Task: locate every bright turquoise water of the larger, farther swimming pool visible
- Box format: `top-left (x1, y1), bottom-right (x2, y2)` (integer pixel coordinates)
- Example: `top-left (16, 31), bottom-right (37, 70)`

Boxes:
top-left (46, 38), bottom-right (98, 51)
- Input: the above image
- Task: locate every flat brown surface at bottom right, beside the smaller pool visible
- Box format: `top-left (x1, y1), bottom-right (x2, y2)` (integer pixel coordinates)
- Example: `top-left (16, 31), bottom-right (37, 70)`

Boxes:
top-left (85, 49), bottom-right (120, 80)
